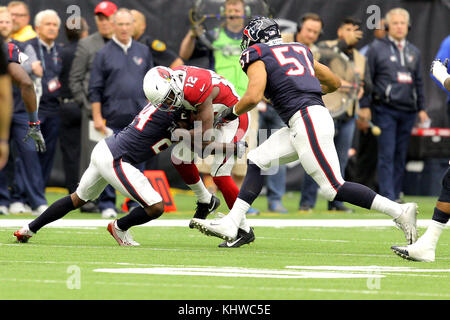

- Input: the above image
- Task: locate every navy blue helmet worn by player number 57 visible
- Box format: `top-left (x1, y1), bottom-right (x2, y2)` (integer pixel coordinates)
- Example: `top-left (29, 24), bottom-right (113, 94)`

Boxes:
top-left (241, 17), bottom-right (281, 50)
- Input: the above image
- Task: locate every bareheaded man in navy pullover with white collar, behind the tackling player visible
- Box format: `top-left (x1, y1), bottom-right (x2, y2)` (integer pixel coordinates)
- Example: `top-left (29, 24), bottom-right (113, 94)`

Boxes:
top-left (89, 8), bottom-right (153, 218)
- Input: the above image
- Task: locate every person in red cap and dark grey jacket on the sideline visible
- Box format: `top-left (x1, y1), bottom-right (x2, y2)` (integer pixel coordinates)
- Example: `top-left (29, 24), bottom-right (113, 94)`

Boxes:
top-left (69, 1), bottom-right (117, 212)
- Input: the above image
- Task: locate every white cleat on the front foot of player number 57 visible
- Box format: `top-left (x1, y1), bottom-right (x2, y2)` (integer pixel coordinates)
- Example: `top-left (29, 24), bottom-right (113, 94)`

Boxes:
top-left (191, 216), bottom-right (238, 242)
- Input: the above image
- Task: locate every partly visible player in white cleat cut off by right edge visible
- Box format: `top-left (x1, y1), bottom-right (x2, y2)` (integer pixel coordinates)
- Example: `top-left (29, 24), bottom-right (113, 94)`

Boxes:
top-left (391, 59), bottom-right (450, 262)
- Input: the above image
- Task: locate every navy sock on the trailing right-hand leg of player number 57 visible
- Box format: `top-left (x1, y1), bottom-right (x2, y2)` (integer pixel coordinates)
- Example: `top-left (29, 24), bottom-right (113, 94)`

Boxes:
top-left (334, 181), bottom-right (377, 209)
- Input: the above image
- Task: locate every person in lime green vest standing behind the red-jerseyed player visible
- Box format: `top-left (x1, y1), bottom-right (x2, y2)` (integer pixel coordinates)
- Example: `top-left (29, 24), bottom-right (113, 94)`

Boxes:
top-left (179, 0), bottom-right (259, 214)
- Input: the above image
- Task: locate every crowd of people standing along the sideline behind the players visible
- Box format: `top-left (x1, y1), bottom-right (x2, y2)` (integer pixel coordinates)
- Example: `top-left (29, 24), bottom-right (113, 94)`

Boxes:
top-left (0, 0), bottom-right (450, 218)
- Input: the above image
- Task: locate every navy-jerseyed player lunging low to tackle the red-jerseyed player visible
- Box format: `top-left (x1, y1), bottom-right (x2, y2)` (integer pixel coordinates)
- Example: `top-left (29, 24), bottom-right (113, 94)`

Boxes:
top-left (14, 104), bottom-right (244, 246)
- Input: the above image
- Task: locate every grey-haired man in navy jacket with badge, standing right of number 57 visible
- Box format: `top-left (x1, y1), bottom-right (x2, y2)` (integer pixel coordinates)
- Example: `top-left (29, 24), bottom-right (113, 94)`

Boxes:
top-left (367, 8), bottom-right (429, 202)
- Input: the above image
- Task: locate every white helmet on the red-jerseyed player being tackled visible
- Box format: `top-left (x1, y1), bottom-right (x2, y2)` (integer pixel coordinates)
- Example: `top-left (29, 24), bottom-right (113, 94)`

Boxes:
top-left (143, 66), bottom-right (184, 112)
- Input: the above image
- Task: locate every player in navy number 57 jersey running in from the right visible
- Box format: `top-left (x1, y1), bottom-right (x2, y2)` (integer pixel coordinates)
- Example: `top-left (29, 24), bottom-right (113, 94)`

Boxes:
top-left (192, 17), bottom-right (417, 247)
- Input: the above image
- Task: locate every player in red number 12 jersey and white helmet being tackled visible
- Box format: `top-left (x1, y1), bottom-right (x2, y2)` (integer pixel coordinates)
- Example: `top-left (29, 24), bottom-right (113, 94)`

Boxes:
top-left (144, 66), bottom-right (250, 228)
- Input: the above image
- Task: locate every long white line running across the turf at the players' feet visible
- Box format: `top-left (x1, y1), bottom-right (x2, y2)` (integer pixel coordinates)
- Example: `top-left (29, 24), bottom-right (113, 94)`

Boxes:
top-left (0, 219), bottom-right (442, 228)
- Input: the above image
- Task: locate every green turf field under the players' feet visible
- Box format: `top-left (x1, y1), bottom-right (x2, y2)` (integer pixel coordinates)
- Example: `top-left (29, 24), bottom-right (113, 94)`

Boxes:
top-left (0, 193), bottom-right (450, 300)
